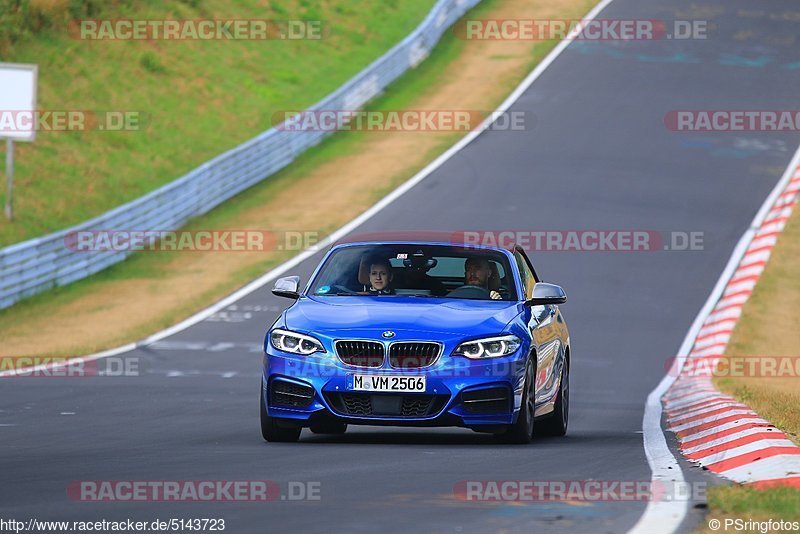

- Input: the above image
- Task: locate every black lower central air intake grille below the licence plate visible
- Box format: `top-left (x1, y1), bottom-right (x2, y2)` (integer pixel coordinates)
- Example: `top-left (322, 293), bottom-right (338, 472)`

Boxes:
top-left (328, 393), bottom-right (448, 417)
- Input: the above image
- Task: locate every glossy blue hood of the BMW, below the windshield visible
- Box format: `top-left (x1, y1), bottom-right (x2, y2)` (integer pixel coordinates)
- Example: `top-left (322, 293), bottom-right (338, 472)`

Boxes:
top-left (285, 296), bottom-right (523, 339)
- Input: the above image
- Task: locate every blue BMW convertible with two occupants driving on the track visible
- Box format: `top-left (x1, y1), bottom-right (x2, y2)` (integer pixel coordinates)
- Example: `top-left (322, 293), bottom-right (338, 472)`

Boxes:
top-left (260, 240), bottom-right (570, 443)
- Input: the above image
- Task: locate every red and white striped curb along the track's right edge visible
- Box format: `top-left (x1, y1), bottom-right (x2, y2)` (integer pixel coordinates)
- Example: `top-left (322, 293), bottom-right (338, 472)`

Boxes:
top-left (662, 167), bottom-right (800, 488)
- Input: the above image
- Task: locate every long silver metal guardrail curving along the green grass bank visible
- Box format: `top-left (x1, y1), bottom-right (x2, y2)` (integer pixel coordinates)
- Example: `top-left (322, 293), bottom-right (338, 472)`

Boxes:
top-left (0, 0), bottom-right (480, 309)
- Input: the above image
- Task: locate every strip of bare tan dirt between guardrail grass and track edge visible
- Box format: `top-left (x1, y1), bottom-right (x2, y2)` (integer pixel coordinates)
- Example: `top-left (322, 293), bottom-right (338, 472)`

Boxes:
top-left (0, 0), bottom-right (591, 356)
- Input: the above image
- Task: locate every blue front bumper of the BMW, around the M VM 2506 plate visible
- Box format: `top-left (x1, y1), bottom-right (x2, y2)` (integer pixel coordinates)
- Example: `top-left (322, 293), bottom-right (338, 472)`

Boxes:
top-left (262, 345), bottom-right (525, 430)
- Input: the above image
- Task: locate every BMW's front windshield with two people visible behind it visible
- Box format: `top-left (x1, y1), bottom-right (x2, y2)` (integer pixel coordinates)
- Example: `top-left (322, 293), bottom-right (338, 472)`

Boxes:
top-left (309, 244), bottom-right (517, 300)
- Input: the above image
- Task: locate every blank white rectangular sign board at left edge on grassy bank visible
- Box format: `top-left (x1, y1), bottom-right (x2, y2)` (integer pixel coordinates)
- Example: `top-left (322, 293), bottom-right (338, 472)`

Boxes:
top-left (0, 63), bottom-right (38, 141)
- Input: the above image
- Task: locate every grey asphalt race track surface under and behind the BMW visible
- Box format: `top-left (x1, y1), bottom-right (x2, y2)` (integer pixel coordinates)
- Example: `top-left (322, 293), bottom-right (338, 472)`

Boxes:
top-left (0, 0), bottom-right (800, 532)
